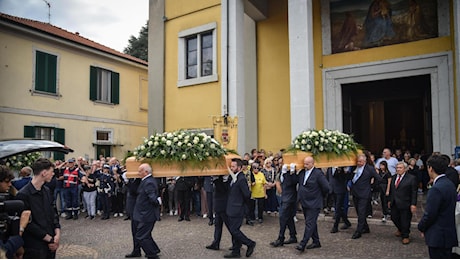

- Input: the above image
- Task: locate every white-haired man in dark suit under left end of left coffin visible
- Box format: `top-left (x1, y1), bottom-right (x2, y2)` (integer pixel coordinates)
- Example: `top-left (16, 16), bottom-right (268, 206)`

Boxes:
top-left (132, 163), bottom-right (161, 258)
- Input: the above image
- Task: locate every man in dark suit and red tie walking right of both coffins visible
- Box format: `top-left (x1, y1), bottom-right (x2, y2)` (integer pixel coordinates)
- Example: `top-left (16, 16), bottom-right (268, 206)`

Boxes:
top-left (388, 162), bottom-right (417, 245)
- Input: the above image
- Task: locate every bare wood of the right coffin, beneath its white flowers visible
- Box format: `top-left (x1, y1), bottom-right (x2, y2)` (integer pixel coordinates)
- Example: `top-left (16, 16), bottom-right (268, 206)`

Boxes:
top-left (283, 151), bottom-right (362, 169)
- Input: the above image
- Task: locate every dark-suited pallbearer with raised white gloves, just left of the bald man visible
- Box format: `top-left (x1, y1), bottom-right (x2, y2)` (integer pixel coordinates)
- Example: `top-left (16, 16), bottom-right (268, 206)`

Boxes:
top-left (270, 164), bottom-right (298, 247)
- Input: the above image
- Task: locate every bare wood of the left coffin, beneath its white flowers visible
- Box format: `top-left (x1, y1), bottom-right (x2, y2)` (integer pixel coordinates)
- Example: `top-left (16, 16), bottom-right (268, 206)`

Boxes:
top-left (125, 154), bottom-right (241, 178)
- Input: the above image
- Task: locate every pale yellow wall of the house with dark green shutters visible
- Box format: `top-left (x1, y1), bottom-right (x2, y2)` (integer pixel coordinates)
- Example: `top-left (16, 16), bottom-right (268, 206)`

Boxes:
top-left (0, 27), bottom-right (148, 158)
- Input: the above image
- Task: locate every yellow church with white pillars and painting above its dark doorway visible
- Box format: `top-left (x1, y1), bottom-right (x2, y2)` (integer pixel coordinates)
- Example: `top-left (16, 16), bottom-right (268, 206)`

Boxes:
top-left (148, 0), bottom-right (460, 155)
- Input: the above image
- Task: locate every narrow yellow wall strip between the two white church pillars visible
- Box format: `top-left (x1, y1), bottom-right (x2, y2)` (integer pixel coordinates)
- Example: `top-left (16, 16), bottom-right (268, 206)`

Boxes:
top-left (255, 0), bottom-right (291, 152)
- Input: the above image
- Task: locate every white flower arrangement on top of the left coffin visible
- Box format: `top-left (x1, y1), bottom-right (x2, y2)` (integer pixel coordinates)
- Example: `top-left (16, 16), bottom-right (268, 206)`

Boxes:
top-left (133, 130), bottom-right (233, 171)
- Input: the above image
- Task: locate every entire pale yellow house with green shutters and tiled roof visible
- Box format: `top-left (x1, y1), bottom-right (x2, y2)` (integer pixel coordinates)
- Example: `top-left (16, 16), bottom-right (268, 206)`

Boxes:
top-left (0, 13), bottom-right (148, 159)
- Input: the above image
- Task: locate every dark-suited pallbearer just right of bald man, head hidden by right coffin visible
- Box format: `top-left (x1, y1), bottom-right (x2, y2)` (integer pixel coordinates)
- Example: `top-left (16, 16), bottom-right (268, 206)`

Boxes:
top-left (326, 167), bottom-right (351, 233)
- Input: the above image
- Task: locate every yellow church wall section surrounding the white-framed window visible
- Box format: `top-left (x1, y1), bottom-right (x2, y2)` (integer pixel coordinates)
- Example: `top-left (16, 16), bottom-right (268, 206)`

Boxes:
top-left (165, 1), bottom-right (221, 131)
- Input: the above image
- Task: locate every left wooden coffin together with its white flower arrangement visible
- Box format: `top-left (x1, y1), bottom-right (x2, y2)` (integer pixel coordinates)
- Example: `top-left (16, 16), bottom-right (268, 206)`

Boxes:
top-left (125, 130), bottom-right (239, 177)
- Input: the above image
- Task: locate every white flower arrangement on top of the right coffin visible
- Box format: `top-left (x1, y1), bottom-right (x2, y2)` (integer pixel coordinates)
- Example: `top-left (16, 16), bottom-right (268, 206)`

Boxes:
top-left (289, 129), bottom-right (361, 156)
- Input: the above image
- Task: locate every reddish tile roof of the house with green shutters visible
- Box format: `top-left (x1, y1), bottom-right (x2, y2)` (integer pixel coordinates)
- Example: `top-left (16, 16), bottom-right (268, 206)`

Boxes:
top-left (0, 13), bottom-right (148, 66)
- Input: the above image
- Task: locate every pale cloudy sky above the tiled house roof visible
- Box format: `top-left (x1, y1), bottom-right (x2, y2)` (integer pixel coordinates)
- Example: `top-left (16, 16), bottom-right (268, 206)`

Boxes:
top-left (0, 0), bottom-right (149, 52)
